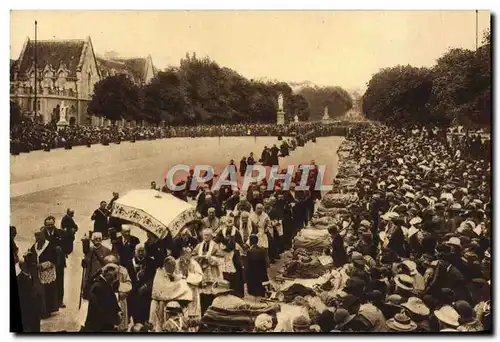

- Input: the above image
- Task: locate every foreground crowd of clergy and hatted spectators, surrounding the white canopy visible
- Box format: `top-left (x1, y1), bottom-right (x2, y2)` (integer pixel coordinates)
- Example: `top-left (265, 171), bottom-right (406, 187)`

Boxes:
top-left (11, 124), bottom-right (492, 332)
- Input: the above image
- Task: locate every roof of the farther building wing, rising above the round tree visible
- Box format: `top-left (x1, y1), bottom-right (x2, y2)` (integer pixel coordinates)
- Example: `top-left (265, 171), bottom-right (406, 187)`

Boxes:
top-left (97, 57), bottom-right (147, 83)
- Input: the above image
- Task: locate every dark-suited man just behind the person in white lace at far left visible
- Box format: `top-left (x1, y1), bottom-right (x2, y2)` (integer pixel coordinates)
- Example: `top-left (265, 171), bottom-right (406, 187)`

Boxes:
top-left (41, 216), bottom-right (68, 308)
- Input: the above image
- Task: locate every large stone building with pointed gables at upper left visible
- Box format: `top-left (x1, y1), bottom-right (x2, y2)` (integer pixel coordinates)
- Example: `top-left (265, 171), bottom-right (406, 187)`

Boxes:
top-left (10, 37), bottom-right (155, 125)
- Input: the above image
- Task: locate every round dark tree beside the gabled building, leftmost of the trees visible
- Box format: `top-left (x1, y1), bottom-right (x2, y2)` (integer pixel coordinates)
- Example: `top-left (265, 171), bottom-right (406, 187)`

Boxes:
top-left (87, 75), bottom-right (143, 121)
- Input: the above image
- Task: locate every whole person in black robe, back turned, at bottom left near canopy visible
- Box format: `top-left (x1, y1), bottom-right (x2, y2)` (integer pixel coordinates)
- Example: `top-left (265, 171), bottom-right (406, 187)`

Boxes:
top-left (83, 264), bottom-right (122, 332)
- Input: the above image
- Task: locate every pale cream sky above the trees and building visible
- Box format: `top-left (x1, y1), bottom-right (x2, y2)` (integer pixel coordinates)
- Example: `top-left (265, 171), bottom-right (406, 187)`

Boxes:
top-left (10, 10), bottom-right (490, 91)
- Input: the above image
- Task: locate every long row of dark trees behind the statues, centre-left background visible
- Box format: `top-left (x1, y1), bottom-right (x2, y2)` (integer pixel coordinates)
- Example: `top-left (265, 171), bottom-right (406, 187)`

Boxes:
top-left (88, 54), bottom-right (352, 125)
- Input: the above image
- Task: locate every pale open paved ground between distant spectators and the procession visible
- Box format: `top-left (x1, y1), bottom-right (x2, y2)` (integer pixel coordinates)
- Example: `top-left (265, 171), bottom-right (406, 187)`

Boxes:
top-left (11, 137), bottom-right (343, 331)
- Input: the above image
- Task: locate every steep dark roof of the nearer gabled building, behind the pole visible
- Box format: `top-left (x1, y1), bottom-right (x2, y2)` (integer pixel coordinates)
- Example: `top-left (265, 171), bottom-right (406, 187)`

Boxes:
top-left (19, 39), bottom-right (85, 77)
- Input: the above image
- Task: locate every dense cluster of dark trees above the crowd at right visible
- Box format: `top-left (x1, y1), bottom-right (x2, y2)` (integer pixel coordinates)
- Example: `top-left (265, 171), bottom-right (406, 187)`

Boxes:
top-left (362, 30), bottom-right (492, 127)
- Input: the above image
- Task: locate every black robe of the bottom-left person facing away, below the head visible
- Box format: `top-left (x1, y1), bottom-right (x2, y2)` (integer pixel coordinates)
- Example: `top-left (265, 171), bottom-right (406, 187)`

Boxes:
top-left (85, 277), bottom-right (121, 332)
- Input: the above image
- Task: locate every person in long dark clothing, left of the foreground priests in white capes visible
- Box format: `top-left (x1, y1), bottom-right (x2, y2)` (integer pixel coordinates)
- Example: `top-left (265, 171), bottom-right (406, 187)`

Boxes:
top-left (127, 245), bottom-right (156, 324)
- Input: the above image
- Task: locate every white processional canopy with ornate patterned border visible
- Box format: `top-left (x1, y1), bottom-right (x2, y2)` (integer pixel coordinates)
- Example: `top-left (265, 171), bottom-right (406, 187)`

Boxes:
top-left (111, 189), bottom-right (197, 239)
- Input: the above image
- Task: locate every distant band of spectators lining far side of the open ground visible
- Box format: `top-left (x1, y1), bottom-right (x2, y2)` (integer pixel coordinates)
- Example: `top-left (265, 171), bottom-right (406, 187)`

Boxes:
top-left (10, 119), bottom-right (356, 155)
